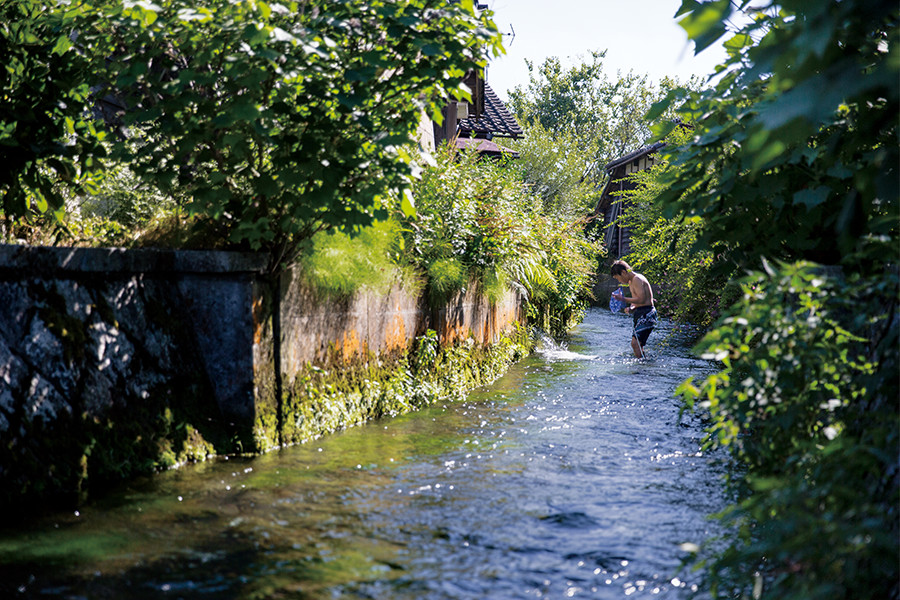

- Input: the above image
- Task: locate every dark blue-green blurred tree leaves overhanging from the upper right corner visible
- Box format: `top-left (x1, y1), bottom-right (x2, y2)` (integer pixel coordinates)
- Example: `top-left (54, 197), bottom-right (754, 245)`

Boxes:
top-left (649, 0), bottom-right (900, 270)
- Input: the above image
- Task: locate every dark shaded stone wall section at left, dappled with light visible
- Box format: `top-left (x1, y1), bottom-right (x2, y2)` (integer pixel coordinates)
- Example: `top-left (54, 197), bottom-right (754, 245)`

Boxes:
top-left (0, 245), bottom-right (265, 507)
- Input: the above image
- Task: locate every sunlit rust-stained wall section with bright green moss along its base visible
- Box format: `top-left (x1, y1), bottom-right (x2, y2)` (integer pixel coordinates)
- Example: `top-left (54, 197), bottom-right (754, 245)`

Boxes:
top-left (270, 272), bottom-right (530, 449)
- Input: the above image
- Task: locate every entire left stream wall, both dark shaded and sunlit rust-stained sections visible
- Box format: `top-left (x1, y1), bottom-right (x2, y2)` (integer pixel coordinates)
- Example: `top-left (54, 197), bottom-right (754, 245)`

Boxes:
top-left (0, 246), bottom-right (528, 514)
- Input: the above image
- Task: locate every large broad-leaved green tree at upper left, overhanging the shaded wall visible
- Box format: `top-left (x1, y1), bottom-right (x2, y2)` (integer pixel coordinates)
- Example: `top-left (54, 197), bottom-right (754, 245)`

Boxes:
top-left (0, 0), bottom-right (500, 258)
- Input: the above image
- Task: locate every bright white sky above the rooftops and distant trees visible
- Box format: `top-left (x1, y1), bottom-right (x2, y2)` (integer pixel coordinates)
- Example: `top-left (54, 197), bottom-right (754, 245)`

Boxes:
top-left (480, 0), bottom-right (725, 100)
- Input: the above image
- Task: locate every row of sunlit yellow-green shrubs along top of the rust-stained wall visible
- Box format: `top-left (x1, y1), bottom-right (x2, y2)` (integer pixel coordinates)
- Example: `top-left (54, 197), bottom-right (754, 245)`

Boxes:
top-left (299, 148), bottom-right (603, 335)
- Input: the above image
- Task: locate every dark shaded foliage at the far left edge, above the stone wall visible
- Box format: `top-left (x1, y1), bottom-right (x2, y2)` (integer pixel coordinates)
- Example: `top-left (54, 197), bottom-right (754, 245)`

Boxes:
top-left (0, 0), bottom-right (105, 218)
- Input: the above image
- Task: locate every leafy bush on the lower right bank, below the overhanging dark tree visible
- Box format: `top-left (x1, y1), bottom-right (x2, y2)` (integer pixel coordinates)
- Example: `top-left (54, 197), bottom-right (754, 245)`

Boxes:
top-left (679, 263), bottom-right (900, 600)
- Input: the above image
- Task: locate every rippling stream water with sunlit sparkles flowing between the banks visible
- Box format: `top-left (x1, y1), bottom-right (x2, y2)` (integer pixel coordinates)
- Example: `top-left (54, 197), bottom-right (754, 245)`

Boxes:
top-left (0, 309), bottom-right (727, 600)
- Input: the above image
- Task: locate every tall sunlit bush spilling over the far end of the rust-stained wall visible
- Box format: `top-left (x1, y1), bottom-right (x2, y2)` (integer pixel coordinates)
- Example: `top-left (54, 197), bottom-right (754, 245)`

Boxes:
top-left (404, 148), bottom-right (600, 333)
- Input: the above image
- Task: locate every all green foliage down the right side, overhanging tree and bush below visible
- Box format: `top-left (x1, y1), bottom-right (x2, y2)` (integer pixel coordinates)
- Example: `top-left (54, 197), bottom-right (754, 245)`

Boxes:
top-left (650, 0), bottom-right (900, 599)
